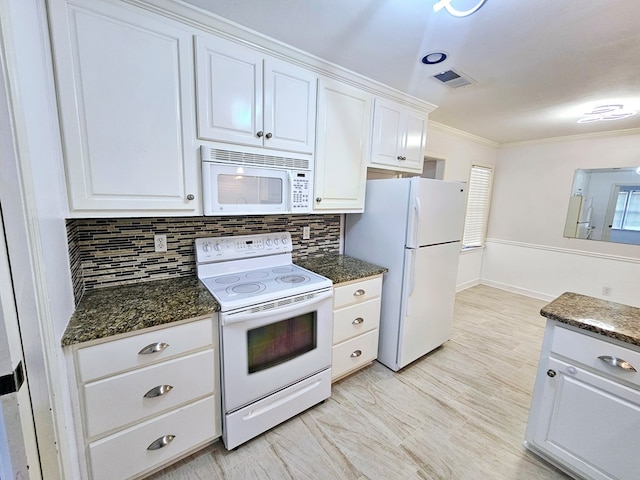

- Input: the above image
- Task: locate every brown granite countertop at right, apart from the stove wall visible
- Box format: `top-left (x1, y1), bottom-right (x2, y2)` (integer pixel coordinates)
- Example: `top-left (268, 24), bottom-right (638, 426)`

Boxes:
top-left (540, 292), bottom-right (640, 346)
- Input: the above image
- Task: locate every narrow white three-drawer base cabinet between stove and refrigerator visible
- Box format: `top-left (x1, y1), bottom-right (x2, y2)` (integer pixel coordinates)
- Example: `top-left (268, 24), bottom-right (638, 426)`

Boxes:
top-left (331, 275), bottom-right (382, 382)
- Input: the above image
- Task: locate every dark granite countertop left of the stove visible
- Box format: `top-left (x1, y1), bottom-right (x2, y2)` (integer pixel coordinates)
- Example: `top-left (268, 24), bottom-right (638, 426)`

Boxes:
top-left (62, 277), bottom-right (220, 346)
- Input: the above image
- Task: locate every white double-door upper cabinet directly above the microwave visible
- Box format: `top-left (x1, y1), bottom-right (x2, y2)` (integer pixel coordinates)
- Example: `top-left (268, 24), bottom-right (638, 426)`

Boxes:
top-left (196, 35), bottom-right (317, 154)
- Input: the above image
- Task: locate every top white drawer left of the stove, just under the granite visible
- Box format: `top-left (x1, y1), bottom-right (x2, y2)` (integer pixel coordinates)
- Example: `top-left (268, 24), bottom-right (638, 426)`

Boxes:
top-left (76, 318), bottom-right (213, 382)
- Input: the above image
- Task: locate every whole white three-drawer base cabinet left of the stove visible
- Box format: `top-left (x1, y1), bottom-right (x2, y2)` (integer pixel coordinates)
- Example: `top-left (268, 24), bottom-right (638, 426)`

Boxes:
top-left (72, 317), bottom-right (221, 480)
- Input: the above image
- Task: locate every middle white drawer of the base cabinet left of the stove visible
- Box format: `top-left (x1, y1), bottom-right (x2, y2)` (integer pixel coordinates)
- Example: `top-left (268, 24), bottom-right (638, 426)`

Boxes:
top-left (84, 350), bottom-right (215, 438)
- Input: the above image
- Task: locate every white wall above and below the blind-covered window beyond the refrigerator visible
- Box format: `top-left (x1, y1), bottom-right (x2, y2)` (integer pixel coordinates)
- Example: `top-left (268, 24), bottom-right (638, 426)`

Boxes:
top-left (426, 122), bottom-right (498, 290)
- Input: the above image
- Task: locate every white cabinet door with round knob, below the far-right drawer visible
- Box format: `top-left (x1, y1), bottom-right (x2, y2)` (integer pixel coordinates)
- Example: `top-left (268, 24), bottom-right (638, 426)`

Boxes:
top-left (534, 358), bottom-right (640, 480)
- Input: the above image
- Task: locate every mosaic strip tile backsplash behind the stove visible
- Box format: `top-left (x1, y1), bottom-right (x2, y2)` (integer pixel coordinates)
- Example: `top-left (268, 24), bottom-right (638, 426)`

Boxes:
top-left (67, 215), bottom-right (340, 303)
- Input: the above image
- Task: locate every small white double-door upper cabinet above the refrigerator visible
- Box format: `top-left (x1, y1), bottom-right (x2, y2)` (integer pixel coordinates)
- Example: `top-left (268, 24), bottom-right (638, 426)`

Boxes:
top-left (369, 98), bottom-right (428, 173)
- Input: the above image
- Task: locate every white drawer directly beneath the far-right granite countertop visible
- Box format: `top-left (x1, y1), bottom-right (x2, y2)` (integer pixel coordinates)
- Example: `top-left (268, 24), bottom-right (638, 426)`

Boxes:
top-left (551, 327), bottom-right (640, 386)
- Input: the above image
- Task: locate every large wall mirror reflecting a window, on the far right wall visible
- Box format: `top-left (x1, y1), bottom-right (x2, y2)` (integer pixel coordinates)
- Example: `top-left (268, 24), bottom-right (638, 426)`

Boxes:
top-left (564, 167), bottom-right (640, 245)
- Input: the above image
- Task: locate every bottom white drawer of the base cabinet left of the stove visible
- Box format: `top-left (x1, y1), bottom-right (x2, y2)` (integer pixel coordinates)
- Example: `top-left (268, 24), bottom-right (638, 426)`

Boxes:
top-left (89, 397), bottom-right (216, 480)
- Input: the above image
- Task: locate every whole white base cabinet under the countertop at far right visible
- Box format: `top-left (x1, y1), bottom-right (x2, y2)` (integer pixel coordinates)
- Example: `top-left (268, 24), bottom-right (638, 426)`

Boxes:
top-left (526, 321), bottom-right (640, 480)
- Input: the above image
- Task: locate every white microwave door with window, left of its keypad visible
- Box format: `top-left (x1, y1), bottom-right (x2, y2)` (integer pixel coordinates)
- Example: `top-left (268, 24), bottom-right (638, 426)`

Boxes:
top-left (202, 162), bottom-right (291, 215)
